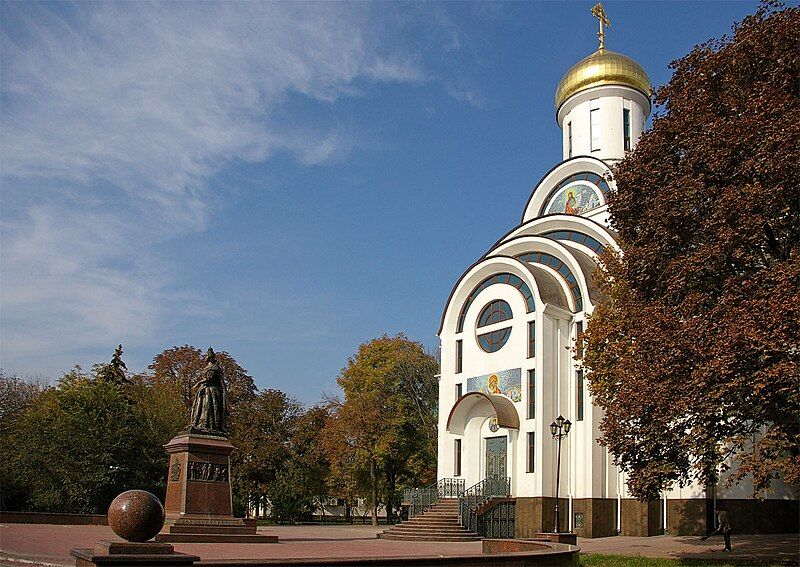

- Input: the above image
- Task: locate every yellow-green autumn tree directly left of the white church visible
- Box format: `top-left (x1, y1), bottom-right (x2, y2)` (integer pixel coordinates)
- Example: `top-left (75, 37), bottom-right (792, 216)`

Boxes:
top-left (325, 335), bottom-right (438, 525)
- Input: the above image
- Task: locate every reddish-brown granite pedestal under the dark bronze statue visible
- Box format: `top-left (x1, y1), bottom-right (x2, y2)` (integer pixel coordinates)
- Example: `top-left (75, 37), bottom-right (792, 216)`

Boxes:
top-left (155, 432), bottom-right (278, 543)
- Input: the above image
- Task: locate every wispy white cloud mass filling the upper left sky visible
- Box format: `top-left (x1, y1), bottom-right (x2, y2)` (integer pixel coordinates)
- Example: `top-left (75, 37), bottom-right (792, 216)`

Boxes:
top-left (0, 2), bottom-right (444, 378)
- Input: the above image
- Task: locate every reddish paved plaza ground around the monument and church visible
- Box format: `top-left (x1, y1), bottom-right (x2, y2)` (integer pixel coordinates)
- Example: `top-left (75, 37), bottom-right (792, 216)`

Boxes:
top-left (0, 524), bottom-right (800, 566)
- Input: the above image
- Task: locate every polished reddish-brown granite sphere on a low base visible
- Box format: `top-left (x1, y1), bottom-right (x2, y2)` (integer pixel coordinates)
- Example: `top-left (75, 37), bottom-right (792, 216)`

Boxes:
top-left (108, 490), bottom-right (164, 542)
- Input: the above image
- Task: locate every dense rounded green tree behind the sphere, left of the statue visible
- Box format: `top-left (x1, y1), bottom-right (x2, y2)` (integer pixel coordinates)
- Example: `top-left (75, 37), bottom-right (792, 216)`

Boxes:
top-left (8, 368), bottom-right (137, 513)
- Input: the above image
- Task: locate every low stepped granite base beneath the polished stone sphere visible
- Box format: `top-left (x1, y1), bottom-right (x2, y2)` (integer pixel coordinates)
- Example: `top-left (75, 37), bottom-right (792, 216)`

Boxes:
top-left (70, 541), bottom-right (200, 567)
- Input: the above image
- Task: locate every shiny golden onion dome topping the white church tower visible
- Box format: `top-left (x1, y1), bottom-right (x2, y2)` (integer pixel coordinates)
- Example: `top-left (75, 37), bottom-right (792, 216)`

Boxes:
top-left (556, 49), bottom-right (652, 108)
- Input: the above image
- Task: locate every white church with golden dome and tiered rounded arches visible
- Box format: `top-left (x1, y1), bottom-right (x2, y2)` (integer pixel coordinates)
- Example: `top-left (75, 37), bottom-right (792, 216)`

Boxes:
top-left (437, 11), bottom-right (797, 537)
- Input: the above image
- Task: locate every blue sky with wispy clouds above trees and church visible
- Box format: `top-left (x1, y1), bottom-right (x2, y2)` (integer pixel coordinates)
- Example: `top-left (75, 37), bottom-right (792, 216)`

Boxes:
top-left (0, 1), bottom-right (757, 403)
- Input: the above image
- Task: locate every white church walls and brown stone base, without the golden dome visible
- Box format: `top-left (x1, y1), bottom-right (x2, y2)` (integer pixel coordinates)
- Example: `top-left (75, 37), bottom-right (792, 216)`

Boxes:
top-left (438, 76), bottom-right (798, 537)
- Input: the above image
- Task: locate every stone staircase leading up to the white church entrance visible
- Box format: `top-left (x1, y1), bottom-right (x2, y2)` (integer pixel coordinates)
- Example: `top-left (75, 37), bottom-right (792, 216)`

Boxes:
top-left (378, 498), bottom-right (481, 541)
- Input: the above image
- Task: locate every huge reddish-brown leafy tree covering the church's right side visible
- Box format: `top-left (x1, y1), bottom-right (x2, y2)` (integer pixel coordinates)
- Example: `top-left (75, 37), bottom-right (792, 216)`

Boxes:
top-left (584, 4), bottom-right (800, 498)
